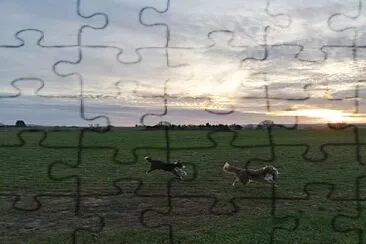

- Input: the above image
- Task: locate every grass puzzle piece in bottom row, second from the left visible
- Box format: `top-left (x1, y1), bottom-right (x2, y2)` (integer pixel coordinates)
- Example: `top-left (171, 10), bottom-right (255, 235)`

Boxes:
top-left (77, 178), bottom-right (167, 243)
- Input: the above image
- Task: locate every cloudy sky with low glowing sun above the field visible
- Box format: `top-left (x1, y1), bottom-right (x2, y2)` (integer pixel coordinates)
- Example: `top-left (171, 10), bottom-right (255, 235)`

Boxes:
top-left (0, 0), bottom-right (366, 126)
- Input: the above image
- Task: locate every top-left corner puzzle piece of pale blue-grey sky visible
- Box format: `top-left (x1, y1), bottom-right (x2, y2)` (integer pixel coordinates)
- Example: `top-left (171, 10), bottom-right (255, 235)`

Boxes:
top-left (0, 0), bottom-right (107, 46)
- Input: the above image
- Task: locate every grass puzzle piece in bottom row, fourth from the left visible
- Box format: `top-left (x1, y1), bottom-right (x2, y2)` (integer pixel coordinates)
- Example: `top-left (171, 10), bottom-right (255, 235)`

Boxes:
top-left (275, 181), bottom-right (354, 243)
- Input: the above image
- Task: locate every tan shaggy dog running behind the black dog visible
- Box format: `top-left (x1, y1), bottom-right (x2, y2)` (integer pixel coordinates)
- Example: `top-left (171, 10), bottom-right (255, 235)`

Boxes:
top-left (223, 162), bottom-right (279, 186)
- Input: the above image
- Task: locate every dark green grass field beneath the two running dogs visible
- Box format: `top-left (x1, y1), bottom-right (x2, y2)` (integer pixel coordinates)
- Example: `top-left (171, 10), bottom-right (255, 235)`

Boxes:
top-left (0, 128), bottom-right (366, 244)
